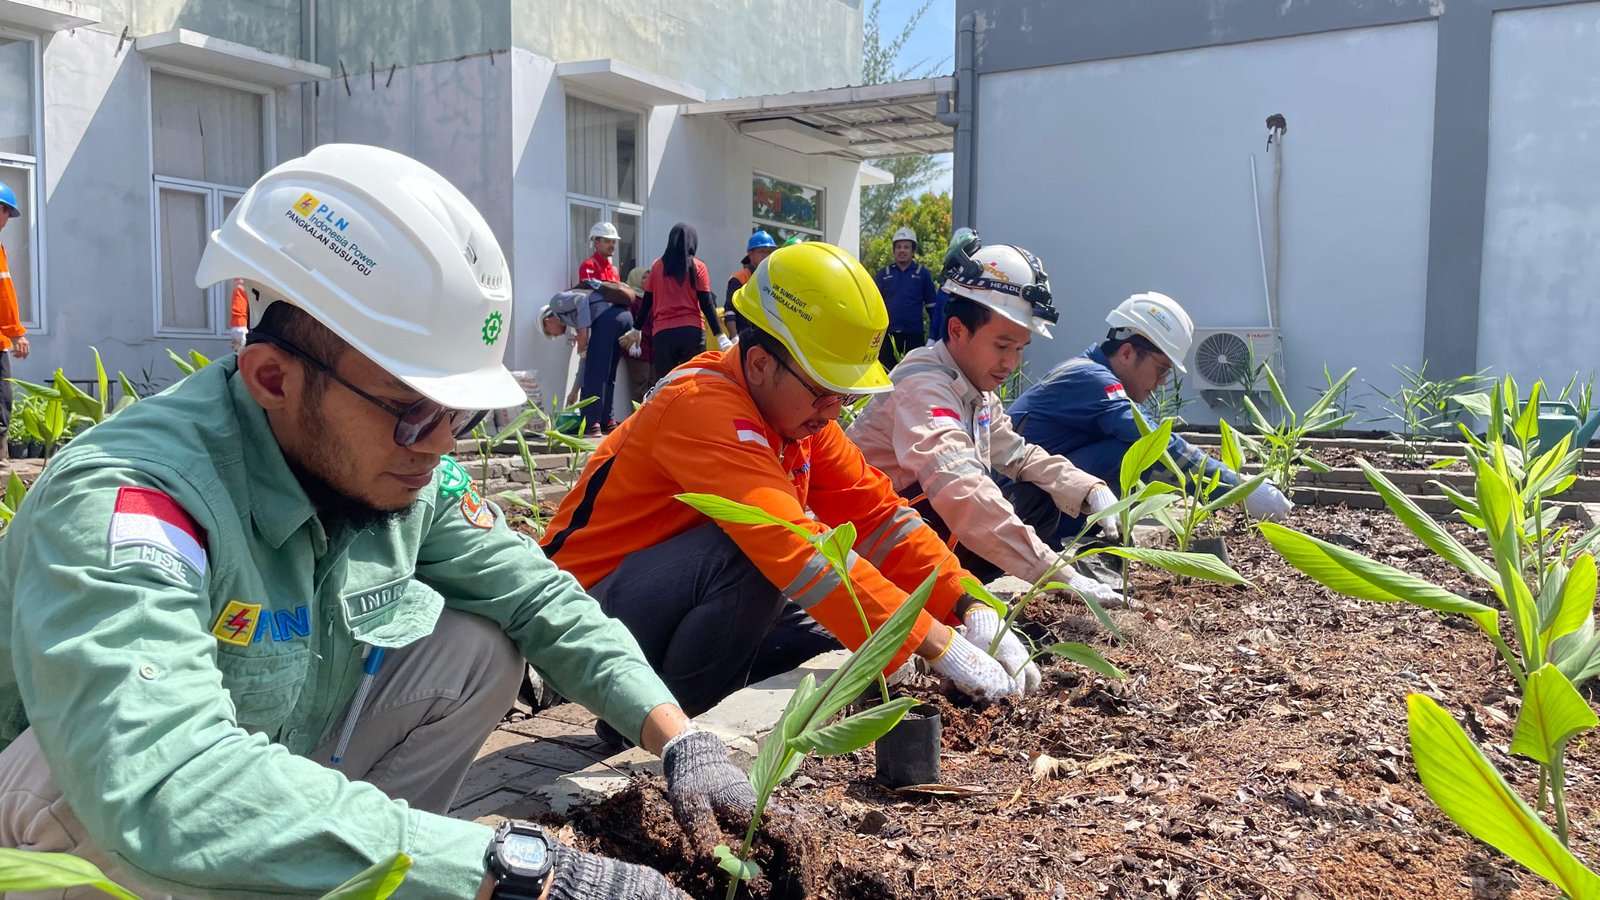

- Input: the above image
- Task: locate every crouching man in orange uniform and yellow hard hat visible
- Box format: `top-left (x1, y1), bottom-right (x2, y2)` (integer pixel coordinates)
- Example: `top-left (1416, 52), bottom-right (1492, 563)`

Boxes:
top-left (544, 242), bottom-right (1022, 730)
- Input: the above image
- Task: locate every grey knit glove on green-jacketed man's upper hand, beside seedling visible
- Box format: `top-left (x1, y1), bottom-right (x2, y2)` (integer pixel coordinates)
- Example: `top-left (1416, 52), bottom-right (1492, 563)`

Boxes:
top-left (661, 732), bottom-right (755, 854)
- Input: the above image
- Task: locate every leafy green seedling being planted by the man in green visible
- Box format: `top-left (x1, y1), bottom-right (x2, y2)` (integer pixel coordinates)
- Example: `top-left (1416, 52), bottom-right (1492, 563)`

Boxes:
top-left (678, 493), bottom-right (938, 900)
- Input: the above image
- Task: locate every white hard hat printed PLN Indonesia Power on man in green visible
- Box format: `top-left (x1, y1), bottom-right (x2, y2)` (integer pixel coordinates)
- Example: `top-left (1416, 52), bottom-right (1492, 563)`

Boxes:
top-left (195, 144), bottom-right (525, 410)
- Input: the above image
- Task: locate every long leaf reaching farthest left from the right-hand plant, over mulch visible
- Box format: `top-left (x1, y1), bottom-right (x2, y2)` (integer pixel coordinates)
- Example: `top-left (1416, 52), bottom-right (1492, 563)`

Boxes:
top-left (1256, 522), bottom-right (1499, 636)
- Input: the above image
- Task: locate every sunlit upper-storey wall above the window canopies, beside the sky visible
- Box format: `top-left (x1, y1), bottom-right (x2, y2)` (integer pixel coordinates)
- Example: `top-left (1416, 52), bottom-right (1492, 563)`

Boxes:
top-left (512, 0), bottom-right (861, 99)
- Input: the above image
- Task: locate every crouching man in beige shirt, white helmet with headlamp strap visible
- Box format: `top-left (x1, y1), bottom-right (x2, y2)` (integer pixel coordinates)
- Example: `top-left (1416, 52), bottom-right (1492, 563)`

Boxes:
top-left (846, 234), bottom-right (1122, 608)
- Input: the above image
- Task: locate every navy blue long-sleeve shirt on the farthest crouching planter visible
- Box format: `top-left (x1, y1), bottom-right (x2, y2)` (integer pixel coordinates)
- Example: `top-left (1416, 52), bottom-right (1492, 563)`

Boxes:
top-left (1006, 344), bottom-right (1240, 490)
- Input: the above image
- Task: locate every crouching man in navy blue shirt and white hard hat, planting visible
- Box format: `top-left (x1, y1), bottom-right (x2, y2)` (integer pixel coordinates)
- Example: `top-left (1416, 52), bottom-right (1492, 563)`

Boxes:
top-left (1006, 291), bottom-right (1294, 548)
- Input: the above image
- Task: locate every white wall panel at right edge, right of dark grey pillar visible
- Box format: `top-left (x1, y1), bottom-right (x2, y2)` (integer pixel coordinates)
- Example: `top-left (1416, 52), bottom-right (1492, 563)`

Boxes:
top-left (1478, 3), bottom-right (1600, 389)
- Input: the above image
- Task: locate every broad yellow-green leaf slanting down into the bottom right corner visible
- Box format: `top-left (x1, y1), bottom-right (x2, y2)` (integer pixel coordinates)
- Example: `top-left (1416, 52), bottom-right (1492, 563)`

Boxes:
top-left (1406, 693), bottom-right (1600, 900)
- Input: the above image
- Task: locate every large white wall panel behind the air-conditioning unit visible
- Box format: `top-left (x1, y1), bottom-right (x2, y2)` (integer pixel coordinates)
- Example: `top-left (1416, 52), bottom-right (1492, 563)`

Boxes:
top-left (974, 22), bottom-right (1435, 420)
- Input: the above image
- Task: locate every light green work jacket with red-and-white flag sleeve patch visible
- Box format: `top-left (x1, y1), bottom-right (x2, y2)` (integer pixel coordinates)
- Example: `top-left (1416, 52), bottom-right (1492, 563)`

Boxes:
top-left (0, 357), bottom-right (674, 897)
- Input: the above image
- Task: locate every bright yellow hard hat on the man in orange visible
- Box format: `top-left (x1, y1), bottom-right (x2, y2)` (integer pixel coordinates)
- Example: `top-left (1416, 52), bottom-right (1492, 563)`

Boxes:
top-left (733, 240), bottom-right (893, 394)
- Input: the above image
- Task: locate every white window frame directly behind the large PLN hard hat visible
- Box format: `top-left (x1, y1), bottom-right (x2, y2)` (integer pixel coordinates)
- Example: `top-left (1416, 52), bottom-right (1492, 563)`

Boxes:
top-left (144, 62), bottom-right (278, 338)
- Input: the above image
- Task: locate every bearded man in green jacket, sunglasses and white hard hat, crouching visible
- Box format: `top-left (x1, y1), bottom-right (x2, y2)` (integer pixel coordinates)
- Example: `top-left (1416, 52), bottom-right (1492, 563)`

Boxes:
top-left (0, 144), bottom-right (754, 900)
